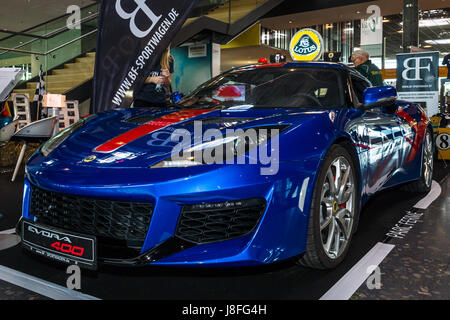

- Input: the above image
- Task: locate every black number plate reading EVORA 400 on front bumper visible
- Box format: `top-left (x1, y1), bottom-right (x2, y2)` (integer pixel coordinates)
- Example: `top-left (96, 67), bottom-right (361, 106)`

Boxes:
top-left (22, 220), bottom-right (97, 270)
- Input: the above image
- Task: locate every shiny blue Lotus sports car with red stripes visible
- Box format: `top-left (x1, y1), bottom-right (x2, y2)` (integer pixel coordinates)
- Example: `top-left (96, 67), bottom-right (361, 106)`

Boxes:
top-left (18, 62), bottom-right (434, 269)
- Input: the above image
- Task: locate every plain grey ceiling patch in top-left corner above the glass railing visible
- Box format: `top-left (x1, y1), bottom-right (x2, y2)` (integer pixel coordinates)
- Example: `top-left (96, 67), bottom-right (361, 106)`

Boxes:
top-left (0, 0), bottom-right (97, 32)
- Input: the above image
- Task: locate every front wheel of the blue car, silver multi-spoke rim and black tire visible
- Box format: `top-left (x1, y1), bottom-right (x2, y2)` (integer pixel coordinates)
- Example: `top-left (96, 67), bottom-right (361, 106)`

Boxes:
top-left (298, 145), bottom-right (360, 269)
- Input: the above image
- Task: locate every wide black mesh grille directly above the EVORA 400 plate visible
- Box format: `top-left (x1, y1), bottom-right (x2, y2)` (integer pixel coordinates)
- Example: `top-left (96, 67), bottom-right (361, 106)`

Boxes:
top-left (30, 188), bottom-right (153, 247)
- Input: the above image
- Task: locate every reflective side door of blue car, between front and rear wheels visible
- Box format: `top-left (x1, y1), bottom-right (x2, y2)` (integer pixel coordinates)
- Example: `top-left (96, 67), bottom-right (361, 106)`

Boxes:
top-left (351, 74), bottom-right (404, 195)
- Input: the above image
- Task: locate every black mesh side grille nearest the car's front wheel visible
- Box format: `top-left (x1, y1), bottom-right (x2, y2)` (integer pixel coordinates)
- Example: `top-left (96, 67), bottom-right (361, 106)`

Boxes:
top-left (175, 198), bottom-right (266, 244)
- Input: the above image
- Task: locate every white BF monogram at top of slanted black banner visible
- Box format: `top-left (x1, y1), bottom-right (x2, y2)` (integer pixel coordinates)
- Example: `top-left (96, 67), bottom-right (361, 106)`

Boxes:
top-left (116, 0), bottom-right (161, 38)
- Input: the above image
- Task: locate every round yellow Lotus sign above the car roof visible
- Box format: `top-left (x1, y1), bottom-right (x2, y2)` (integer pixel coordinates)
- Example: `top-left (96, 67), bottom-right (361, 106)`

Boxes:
top-left (290, 29), bottom-right (323, 61)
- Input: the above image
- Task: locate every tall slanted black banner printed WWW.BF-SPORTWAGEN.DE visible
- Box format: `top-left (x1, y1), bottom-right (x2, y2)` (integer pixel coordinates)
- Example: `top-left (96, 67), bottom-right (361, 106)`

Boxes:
top-left (91, 0), bottom-right (198, 113)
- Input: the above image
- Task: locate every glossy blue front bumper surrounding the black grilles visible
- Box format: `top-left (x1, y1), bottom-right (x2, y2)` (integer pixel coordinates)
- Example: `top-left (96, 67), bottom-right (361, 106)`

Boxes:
top-left (22, 160), bottom-right (319, 266)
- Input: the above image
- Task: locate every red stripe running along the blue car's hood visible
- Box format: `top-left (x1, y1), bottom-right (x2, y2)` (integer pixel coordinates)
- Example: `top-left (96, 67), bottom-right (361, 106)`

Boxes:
top-left (94, 109), bottom-right (212, 153)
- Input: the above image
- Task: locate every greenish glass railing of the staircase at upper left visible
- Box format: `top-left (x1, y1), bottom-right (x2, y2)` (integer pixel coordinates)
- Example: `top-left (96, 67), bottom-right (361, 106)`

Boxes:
top-left (0, 4), bottom-right (99, 81)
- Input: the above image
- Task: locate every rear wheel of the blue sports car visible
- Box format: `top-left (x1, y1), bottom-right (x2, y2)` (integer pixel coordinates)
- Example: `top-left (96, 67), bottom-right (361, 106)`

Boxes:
top-left (403, 129), bottom-right (434, 193)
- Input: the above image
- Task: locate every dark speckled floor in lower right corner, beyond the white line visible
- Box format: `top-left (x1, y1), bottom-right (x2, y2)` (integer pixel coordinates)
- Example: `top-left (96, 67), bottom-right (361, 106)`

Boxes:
top-left (352, 179), bottom-right (450, 300)
